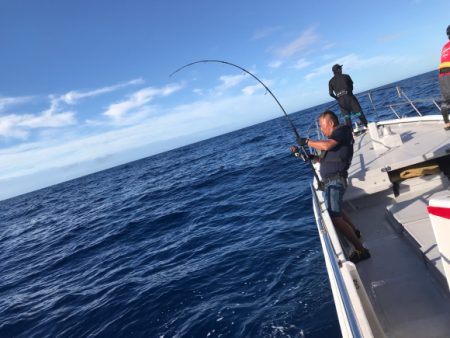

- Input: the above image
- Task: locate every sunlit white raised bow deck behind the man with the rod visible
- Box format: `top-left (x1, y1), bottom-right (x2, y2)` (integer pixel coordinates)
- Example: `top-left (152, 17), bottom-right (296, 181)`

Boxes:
top-left (346, 116), bottom-right (450, 200)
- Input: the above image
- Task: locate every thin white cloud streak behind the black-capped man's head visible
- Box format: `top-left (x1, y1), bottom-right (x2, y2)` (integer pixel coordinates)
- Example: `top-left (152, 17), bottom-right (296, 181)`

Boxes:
top-left (305, 54), bottom-right (401, 80)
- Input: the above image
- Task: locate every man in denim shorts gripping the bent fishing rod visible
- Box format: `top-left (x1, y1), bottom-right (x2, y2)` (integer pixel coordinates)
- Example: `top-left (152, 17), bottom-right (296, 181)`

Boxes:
top-left (291, 110), bottom-right (370, 263)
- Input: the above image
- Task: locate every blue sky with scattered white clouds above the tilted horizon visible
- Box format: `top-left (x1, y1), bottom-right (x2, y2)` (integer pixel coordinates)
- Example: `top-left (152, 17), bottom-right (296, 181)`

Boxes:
top-left (0, 0), bottom-right (450, 199)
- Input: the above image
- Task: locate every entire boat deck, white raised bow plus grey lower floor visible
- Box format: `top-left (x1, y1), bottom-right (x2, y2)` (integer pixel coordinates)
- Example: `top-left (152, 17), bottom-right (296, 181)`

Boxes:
top-left (346, 117), bottom-right (450, 337)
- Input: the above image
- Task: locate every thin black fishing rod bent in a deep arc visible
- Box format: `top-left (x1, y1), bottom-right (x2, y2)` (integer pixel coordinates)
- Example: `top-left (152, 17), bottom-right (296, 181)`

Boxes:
top-left (169, 60), bottom-right (322, 188)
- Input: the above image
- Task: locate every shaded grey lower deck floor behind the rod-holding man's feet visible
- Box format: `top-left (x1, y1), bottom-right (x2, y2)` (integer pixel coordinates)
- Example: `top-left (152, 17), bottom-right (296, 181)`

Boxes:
top-left (350, 190), bottom-right (450, 337)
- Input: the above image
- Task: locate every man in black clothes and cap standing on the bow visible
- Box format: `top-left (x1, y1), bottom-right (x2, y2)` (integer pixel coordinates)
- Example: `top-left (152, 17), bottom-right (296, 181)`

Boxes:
top-left (328, 64), bottom-right (367, 127)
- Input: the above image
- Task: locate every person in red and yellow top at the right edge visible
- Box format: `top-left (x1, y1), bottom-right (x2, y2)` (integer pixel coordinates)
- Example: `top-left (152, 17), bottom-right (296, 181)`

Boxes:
top-left (439, 26), bottom-right (450, 130)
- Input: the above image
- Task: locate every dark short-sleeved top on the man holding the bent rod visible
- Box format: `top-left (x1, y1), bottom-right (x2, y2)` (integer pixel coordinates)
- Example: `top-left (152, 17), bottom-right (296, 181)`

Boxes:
top-left (320, 125), bottom-right (354, 179)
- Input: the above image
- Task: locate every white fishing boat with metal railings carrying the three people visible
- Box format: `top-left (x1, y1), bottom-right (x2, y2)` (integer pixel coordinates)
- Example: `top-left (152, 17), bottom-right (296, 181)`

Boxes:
top-left (311, 88), bottom-right (450, 337)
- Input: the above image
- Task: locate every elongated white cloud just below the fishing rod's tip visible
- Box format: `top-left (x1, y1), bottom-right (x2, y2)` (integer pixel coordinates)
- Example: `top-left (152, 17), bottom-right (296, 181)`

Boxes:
top-left (103, 85), bottom-right (181, 121)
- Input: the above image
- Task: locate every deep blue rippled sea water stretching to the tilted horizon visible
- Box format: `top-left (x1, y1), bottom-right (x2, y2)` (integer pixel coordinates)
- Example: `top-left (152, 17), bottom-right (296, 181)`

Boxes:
top-left (0, 72), bottom-right (439, 338)
